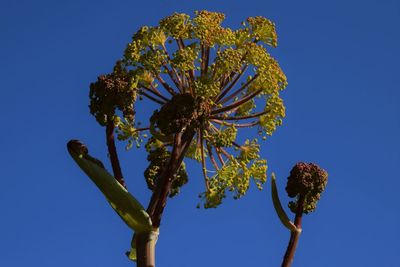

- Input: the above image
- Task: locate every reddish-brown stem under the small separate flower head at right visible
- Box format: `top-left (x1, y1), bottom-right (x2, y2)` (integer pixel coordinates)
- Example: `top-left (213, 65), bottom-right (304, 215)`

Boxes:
top-left (282, 196), bottom-right (304, 267)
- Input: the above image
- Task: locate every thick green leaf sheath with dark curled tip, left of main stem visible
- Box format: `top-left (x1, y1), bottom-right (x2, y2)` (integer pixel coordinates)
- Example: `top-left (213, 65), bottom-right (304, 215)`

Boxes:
top-left (67, 140), bottom-right (152, 233)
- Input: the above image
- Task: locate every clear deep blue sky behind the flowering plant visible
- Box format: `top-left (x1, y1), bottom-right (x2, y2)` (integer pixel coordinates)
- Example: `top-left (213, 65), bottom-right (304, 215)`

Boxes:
top-left (0, 0), bottom-right (400, 267)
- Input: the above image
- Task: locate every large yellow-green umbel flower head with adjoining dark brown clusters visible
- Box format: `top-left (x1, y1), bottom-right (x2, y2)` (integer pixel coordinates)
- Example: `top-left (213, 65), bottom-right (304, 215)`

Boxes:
top-left (90, 11), bottom-right (287, 208)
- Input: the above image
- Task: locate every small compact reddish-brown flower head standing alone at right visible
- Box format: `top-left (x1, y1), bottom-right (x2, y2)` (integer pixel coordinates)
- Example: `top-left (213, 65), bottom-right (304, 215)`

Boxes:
top-left (286, 162), bottom-right (328, 214)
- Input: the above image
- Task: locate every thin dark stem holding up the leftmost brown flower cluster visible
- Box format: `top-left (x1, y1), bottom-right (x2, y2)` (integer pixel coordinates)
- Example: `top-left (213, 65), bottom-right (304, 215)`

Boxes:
top-left (106, 120), bottom-right (126, 188)
